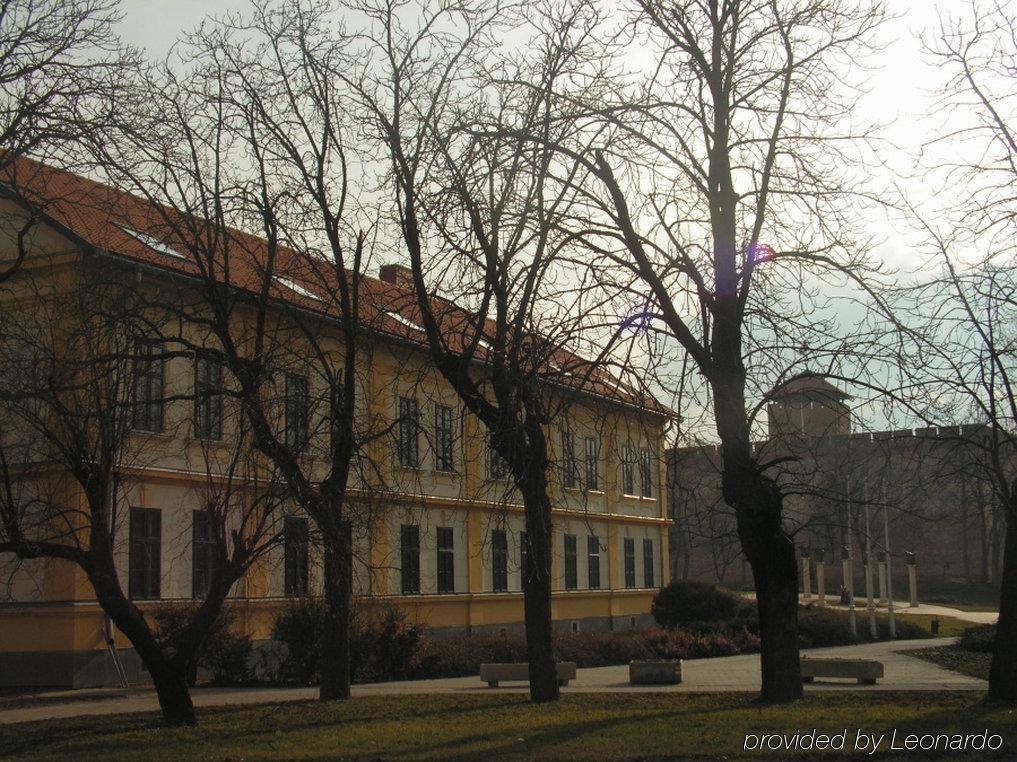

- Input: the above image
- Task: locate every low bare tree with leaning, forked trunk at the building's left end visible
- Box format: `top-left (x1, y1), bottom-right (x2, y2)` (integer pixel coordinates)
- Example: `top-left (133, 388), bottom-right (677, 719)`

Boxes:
top-left (0, 245), bottom-right (277, 724)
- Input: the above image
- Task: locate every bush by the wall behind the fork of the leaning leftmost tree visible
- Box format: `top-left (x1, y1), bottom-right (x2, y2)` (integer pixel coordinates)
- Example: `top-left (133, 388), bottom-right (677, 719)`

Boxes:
top-left (153, 603), bottom-right (253, 686)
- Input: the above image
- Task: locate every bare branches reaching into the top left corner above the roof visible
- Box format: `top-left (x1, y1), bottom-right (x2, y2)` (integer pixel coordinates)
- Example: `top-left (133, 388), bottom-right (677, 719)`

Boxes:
top-left (0, 0), bottom-right (138, 282)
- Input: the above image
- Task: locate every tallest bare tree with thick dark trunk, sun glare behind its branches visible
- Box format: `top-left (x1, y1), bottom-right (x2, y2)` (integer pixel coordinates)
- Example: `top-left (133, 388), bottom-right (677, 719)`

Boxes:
top-left (563, 0), bottom-right (883, 702)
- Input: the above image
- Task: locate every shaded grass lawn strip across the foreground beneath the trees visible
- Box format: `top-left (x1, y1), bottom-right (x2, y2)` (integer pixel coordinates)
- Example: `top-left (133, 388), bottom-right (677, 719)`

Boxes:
top-left (0, 691), bottom-right (1017, 760)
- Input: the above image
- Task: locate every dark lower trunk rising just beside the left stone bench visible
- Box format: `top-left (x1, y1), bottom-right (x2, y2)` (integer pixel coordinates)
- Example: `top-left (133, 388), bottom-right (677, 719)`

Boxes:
top-left (522, 485), bottom-right (559, 702)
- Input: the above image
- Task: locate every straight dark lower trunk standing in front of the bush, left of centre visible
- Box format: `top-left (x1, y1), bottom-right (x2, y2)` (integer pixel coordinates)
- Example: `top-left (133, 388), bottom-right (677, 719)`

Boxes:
top-left (318, 522), bottom-right (353, 701)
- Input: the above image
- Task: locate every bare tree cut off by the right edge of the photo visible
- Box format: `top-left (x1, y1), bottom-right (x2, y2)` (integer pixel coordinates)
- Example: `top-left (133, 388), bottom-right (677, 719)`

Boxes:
top-left (905, 2), bottom-right (1017, 704)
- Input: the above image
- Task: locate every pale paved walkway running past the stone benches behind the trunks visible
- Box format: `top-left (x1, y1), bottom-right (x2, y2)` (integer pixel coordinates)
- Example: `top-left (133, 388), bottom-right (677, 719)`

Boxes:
top-left (0, 638), bottom-right (986, 724)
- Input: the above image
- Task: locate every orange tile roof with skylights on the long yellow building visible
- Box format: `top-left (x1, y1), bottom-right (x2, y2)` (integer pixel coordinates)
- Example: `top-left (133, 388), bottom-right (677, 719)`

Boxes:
top-left (0, 158), bottom-right (673, 415)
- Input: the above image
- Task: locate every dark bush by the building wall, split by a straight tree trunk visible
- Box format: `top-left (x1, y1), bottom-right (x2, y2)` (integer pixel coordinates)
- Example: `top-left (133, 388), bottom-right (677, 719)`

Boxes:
top-left (272, 598), bottom-right (420, 685)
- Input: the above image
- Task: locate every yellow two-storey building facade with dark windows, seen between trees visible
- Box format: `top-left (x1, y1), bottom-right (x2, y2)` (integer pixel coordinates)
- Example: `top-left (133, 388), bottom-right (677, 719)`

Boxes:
top-left (0, 157), bottom-right (668, 686)
